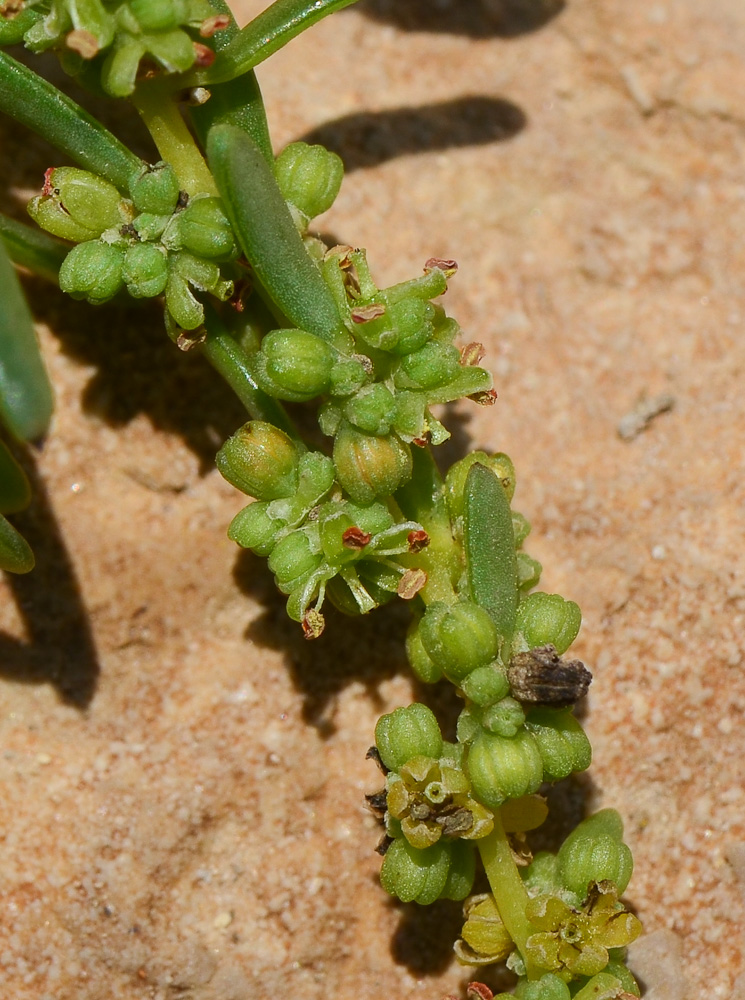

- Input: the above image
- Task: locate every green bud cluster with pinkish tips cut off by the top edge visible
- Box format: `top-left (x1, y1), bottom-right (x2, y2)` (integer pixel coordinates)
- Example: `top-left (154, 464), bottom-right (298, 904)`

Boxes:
top-left (4, 0), bottom-right (230, 97)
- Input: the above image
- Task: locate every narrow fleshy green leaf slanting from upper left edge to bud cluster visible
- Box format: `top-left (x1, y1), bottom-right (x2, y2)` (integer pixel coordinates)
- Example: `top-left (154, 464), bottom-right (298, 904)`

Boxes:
top-left (0, 52), bottom-right (142, 193)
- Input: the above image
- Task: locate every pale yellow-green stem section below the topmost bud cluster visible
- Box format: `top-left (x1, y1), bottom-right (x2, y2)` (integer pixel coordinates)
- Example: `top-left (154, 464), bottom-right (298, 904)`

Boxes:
top-left (132, 80), bottom-right (217, 195)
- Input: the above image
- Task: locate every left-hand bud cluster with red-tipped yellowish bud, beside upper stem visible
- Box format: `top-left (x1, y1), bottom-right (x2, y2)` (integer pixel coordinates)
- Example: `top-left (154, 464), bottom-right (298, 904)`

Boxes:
top-left (28, 163), bottom-right (237, 330)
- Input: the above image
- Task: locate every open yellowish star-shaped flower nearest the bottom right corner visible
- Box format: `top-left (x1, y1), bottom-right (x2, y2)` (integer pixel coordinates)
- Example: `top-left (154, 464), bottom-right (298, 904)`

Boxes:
top-left (525, 882), bottom-right (641, 982)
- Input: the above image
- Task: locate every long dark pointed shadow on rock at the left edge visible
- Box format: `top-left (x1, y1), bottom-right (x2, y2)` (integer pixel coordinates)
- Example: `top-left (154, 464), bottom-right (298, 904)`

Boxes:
top-left (0, 447), bottom-right (100, 709)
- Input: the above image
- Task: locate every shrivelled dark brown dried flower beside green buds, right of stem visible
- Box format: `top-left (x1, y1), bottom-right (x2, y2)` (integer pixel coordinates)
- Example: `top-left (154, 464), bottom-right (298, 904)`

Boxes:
top-left (507, 645), bottom-right (592, 708)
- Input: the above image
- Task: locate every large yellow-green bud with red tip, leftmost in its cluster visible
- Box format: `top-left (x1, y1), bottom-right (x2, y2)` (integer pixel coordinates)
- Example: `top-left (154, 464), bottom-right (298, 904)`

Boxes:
top-left (28, 167), bottom-right (123, 242)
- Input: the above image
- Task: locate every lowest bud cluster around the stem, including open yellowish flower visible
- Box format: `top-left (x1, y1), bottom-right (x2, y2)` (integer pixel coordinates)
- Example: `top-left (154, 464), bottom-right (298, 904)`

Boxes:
top-left (455, 809), bottom-right (641, 1000)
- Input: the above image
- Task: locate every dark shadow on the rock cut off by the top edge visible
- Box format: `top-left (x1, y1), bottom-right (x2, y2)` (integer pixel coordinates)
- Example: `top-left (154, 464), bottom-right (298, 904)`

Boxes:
top-left (358, 0), bottom-right (566, 38)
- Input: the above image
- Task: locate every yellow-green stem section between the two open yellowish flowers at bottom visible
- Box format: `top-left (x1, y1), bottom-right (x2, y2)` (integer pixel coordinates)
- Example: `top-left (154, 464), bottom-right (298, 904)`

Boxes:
top-left (478, 812), bottom-right (543, 980)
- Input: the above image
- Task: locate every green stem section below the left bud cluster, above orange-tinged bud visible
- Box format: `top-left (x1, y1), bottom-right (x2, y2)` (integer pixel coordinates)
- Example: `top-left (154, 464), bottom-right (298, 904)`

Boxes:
top-left (201, 306), bottom-right (305, 448)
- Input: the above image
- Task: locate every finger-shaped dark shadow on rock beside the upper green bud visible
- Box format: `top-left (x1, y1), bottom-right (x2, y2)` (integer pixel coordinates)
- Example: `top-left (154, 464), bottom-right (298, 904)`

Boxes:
top-left (302, 95), bottom-right (527, 173)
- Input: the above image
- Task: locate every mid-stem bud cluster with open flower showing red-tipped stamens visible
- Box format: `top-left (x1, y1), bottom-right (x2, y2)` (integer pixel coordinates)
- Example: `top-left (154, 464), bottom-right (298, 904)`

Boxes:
top-left (217, 420), bottom-right (428, 638)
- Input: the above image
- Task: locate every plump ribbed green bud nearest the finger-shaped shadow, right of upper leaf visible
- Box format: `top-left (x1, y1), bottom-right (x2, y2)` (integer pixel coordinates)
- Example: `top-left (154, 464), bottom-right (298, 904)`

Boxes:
top-left (274, 142), bottom-right (344, 223)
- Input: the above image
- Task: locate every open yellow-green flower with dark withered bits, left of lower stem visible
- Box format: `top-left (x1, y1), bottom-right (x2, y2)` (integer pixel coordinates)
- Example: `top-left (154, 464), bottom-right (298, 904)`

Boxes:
top-left (386, 757), bottom-right (494, 850)
